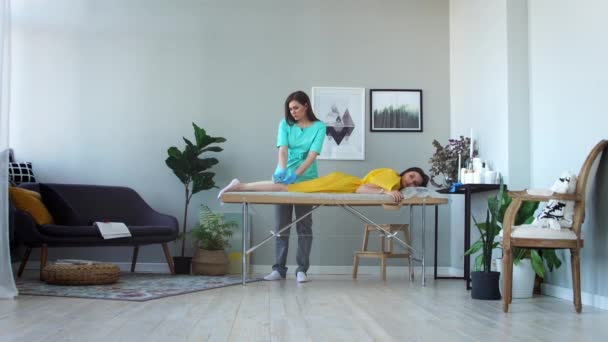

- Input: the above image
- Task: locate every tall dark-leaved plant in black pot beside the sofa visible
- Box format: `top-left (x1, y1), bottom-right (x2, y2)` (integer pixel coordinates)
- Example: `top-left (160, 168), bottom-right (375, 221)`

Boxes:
top-left (165, 122), bottom-right (226, 274)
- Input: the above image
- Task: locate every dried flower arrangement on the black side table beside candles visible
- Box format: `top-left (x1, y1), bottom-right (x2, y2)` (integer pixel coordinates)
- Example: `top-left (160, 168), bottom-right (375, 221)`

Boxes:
top-left (429, 135), bottom-right (477, 187)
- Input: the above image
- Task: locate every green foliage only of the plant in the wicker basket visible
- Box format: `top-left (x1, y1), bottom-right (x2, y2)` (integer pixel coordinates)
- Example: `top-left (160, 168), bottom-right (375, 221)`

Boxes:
top-left (190, 205), bottom-right (238, 251)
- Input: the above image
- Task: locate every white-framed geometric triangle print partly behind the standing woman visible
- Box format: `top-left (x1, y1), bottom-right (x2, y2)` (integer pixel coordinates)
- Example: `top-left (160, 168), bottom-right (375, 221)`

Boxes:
top-left (312, 87), bottom-right (365, 160)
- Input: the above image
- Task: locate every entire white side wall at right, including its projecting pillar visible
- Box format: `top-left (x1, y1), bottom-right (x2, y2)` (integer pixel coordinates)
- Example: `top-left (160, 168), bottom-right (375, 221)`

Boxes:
top-left (450, 0), bottom-right (608, 306)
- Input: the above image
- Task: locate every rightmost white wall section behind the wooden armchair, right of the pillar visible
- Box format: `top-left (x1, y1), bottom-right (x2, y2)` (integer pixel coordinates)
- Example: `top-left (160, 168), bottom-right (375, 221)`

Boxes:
top-left (529, 0), bottom-right (608, 296)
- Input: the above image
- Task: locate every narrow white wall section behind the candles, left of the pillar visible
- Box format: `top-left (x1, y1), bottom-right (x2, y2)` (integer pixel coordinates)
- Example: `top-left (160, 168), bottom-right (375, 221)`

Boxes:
top-left (450, 0), bottom-right (510, 268)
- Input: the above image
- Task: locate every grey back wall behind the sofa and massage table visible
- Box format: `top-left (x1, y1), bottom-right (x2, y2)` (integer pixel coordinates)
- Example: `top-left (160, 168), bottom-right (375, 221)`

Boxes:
top-left (10, 0), bottom-right (449, 265)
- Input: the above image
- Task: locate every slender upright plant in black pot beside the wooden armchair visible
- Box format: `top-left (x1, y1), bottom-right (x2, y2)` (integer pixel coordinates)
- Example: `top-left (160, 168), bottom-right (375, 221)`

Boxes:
top-left (465, 180), bottom-right (505, 299)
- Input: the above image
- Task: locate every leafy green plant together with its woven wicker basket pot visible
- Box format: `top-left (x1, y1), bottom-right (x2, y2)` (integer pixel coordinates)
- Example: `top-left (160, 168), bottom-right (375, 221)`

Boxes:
top-left (190, 205), bottom-right (238, 275)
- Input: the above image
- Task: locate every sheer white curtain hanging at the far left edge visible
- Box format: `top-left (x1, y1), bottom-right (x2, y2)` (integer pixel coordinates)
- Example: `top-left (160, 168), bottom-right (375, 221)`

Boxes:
top-left (0, 0), bottom-right (17, 298)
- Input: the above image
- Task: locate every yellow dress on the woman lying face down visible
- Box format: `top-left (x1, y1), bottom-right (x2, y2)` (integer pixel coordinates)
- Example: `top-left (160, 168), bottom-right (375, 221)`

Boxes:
top-left (287, 168), bottom-right (401, 193)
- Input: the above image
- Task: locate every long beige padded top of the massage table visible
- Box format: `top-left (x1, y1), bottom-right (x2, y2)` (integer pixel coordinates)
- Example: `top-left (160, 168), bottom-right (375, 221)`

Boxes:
top-left (221, 192), bottom-right (448, 206)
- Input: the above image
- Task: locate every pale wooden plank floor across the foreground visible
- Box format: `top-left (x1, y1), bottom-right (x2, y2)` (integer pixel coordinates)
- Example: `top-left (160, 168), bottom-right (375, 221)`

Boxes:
top-left (0, 275), bottom-right (608, 342)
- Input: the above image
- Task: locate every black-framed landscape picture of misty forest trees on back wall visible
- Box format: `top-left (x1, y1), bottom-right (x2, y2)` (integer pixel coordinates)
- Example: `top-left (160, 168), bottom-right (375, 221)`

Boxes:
top-left (369, 89), bottom-right (422, 132)
